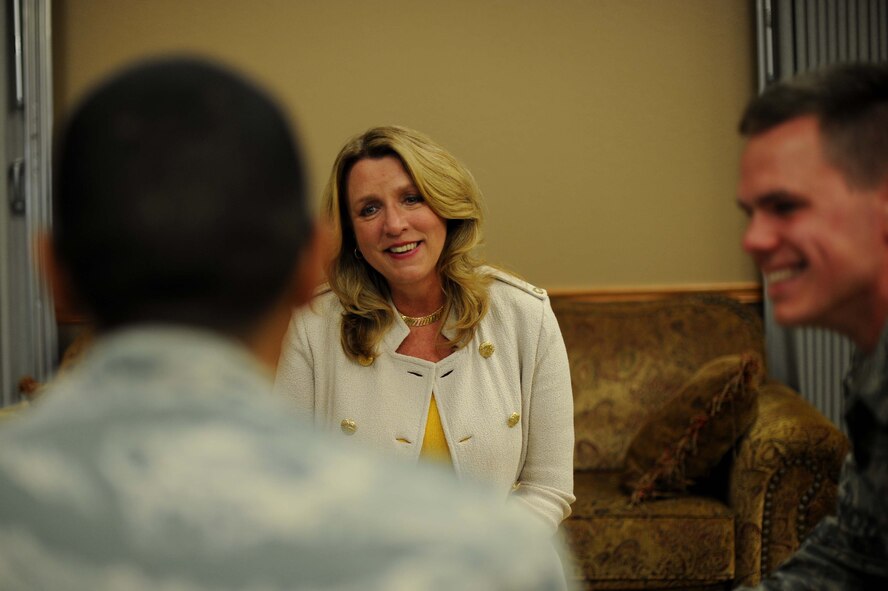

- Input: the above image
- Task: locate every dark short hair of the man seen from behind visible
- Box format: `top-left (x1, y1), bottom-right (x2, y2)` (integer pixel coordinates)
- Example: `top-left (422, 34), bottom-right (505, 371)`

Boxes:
top-left (53, 58), bottom-right (312, 333)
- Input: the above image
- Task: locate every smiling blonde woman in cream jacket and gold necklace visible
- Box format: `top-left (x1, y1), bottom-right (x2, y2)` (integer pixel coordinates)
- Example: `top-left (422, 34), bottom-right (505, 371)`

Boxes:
top-left (275, 127), bottom-right (574, 531)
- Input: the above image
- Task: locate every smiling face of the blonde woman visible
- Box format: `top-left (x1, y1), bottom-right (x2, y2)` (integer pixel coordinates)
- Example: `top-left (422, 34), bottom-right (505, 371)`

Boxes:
top-left (347, 156), bottom-right (447, 291)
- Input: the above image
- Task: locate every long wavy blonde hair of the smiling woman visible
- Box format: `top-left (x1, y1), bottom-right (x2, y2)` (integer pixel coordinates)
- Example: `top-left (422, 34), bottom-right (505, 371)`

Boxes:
top-left (323, 126), bottom-right (491, 359)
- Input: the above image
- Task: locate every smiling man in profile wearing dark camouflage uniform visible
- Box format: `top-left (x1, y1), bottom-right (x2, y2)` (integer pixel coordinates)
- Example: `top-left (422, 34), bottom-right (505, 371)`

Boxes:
top-left (738, 64), bottom-right (888, 589)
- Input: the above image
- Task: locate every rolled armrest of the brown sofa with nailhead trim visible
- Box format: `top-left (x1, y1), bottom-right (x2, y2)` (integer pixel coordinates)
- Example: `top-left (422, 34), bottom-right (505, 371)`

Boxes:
top-left (728, 382), bottom-right (849, 585)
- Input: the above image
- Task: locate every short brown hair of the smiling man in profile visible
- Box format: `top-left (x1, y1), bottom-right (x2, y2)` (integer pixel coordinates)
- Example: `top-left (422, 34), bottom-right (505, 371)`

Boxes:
top-left (740, 63), bottom-right (888, 189)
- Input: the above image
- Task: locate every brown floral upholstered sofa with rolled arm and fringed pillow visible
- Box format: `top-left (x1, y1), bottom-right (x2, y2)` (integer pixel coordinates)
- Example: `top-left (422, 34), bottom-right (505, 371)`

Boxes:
top-left (552, 295), bottom-right (848, 589)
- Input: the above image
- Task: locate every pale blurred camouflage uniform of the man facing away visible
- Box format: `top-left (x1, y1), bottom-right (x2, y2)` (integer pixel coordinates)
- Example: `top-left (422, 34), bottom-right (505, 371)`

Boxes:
top-left (0, 328), bottom-right (565, 591)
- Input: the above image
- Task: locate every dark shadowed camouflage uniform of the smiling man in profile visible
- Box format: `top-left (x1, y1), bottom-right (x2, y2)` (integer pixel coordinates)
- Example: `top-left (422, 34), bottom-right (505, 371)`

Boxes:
top-left (740, 326), bottom-right (888, 590)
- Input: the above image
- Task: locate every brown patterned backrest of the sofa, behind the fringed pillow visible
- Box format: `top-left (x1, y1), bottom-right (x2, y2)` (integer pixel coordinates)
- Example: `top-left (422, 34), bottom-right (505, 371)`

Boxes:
top-left (552, 295), bottom-right (764, 470)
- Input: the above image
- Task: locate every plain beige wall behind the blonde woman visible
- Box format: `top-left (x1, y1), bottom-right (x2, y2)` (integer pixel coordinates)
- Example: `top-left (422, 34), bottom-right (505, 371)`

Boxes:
top-left (53, 0), bottom-right (757, 289)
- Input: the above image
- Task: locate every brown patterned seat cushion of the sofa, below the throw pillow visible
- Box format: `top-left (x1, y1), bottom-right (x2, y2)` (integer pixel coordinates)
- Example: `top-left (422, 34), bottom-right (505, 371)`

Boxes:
top-left (563, 472), bottom-right (734, 589)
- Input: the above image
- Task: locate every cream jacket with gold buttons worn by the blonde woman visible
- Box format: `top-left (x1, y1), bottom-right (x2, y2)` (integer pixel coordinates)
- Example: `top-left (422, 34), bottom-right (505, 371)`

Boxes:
top-left (275, 269), bottom-right (575, 531)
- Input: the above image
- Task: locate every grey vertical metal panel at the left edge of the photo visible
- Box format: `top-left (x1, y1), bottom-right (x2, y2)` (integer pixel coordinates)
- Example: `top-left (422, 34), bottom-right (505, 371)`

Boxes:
top-left (0, 0), bottom-right (56, 406)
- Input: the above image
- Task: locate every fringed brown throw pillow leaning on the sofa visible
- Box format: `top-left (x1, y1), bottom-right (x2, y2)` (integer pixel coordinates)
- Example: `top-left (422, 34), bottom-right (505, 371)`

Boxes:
top-left (623, 353), bottom-right (762, 504)
